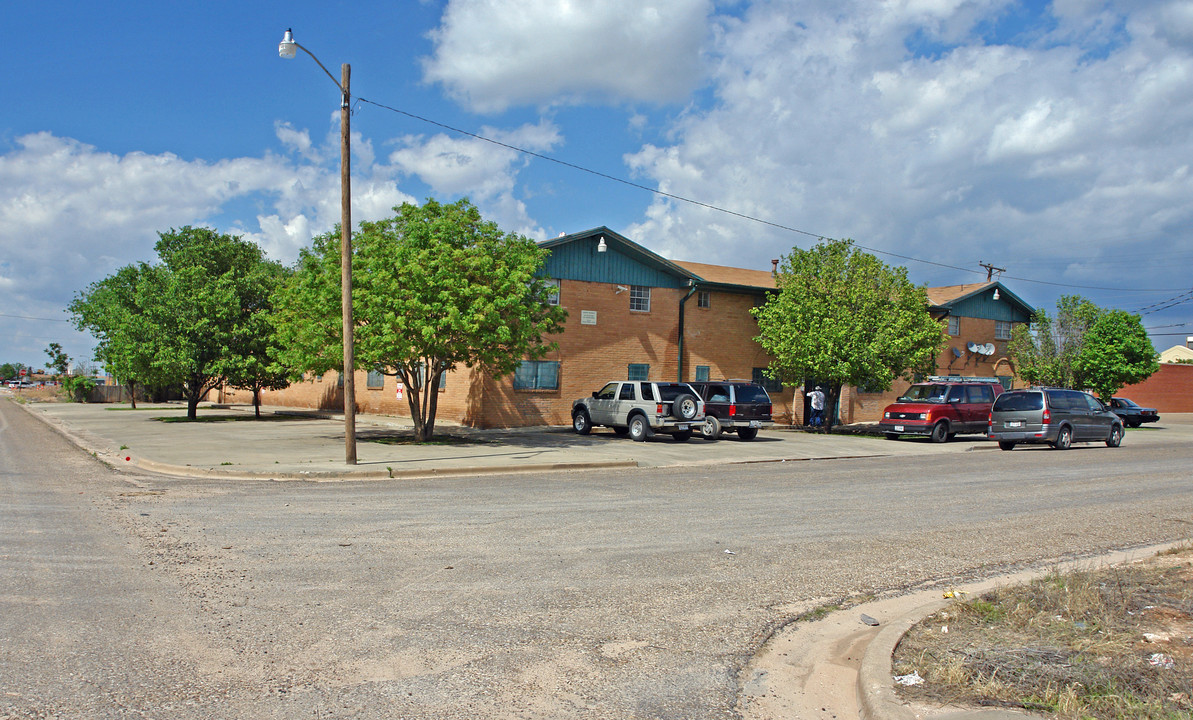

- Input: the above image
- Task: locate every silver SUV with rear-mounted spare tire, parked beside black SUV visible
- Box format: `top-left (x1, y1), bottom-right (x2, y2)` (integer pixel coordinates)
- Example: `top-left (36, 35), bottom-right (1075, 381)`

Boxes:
top-left (571, 380), bottom-right (704, 442)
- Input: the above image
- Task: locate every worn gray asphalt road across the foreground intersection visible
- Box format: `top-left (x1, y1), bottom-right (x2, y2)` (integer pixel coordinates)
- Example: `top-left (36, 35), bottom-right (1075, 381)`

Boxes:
top-left (0, 403), bottom-right (1193, 719)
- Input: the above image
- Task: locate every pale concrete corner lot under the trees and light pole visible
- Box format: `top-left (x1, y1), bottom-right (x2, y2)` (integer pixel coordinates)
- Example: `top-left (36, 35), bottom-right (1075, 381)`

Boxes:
top-left (24, 395), bottom-right (994, 480)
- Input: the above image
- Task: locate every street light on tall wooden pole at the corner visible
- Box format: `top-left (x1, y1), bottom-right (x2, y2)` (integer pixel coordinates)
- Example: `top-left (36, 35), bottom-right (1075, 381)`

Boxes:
top-left (278, 30), bottom-right (357, 465)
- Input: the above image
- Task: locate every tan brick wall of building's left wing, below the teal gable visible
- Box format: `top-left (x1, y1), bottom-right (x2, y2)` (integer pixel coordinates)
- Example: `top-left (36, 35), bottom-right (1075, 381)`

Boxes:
top-left (220, 280), bottom-right (793, 428)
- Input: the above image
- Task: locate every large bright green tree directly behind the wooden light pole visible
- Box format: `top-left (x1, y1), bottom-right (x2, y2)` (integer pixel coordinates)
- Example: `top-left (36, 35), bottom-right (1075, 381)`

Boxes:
top-left (277, 199), bottom-right (567, 440)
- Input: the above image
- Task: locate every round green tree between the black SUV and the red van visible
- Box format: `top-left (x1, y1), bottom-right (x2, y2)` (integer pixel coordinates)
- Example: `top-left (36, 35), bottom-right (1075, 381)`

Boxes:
top-left (754, 240), bottom-right (945, 432)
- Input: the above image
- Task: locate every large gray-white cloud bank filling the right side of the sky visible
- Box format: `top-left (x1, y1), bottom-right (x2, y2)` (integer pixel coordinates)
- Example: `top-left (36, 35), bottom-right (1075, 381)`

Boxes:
top-left (626, 0), bottom-right (1193, 312)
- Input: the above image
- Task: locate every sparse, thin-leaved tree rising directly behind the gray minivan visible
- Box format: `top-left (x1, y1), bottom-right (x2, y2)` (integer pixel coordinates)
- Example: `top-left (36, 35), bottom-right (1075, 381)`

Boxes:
top-left (1007, 296), bottom-right (1104, 387)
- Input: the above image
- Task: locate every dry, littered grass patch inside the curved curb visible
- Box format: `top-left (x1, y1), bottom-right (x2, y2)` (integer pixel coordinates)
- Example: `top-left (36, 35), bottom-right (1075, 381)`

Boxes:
top-left (894, 547), bottom-right (1193, 720)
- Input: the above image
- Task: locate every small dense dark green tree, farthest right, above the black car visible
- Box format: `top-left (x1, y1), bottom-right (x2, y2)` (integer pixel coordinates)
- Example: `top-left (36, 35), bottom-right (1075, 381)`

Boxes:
top-left (1074, 310), bottom-right (1160, 402)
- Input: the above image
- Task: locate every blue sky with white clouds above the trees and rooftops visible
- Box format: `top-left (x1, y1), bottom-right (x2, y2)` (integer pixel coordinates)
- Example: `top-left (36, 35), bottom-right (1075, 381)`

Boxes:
top-left (0, 0), bottom-right (1193, 365)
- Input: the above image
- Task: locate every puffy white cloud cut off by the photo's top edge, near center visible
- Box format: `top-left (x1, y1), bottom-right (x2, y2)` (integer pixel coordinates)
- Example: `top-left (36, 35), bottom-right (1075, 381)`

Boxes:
top-left (424, 0), bottom-right (712, 112)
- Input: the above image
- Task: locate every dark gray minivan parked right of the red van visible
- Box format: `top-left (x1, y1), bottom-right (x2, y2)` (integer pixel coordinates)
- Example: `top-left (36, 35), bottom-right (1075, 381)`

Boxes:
top-left (987, 387), bottom-right (1123, 449)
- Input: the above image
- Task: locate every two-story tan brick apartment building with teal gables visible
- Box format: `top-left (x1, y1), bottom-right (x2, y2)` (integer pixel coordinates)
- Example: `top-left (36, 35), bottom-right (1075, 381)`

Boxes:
top-left (220, 228), bottom-right (1032, 428)
